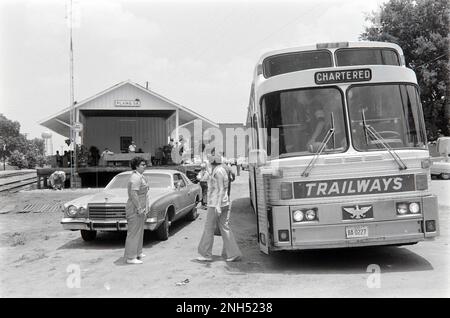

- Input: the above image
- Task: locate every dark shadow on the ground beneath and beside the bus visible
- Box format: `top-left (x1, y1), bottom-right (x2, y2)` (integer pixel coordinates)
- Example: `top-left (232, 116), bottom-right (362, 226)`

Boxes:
top-left (227, 198), bottom-right (433, 274)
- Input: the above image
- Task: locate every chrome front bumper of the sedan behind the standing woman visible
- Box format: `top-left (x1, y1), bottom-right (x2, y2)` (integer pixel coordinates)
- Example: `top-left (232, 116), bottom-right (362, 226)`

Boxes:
top-left (61, 218), bottom-right (158, 231)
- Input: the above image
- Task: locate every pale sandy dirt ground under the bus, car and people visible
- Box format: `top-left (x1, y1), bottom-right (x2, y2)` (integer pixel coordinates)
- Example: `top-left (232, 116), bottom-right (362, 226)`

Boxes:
top-left (0, 172), bottom-right (450, 298)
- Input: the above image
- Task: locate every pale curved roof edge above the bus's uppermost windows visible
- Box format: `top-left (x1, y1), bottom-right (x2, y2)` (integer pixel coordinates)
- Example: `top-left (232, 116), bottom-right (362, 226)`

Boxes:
top-left (258, 41), bottom-right (403, 65)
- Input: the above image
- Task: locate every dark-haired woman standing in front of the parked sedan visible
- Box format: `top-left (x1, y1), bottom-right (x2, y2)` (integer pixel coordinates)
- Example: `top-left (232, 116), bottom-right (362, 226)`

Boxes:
top-left (125, 157), bottom-right (149, 264)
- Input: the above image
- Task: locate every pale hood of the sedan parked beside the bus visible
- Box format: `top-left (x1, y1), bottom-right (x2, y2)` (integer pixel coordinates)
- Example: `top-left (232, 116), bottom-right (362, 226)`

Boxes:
top-left (65, 188), bottom-right (173, 207)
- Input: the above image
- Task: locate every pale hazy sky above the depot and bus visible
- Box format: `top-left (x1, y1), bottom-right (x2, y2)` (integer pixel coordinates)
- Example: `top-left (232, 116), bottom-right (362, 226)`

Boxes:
top-left (0, 0), bottom-right (385, 151)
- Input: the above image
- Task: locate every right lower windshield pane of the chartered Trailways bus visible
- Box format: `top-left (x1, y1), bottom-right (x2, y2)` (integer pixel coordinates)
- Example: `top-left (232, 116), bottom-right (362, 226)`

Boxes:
top-left (347, 84), bottom-right (426, 151)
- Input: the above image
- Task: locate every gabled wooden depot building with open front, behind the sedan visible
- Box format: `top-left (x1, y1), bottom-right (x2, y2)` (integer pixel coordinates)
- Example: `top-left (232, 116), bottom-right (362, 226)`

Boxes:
top-left (39, 81), bottom-right (219, 156)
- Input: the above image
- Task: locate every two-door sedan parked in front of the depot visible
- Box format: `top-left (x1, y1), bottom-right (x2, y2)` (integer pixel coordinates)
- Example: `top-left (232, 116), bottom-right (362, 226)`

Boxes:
top-left (61, 169), bottom-right (202, 241)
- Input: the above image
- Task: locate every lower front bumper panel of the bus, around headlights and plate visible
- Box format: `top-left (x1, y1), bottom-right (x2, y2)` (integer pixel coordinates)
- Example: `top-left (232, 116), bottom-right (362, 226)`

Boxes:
top-left (271, 196), bottom-right (439, 251)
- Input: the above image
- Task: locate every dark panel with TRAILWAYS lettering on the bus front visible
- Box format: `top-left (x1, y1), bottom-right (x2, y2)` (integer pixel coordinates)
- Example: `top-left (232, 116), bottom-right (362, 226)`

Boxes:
top-left (294, 174), bottom-right (415, 199)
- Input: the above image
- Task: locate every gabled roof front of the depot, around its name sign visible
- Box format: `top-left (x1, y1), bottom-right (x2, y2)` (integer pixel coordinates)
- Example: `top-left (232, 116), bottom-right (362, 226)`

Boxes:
top-left (38, 80), bottom-right (219, 137)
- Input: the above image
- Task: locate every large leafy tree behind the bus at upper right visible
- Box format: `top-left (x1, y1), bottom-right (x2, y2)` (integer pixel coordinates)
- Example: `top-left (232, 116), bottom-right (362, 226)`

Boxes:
top-left (360, 0), bottom-right (450, 140)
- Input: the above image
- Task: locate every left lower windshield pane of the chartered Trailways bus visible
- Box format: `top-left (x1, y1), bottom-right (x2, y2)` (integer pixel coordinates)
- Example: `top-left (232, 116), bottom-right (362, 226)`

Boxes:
top-left (261, 88), bottom-right (347, 158)
